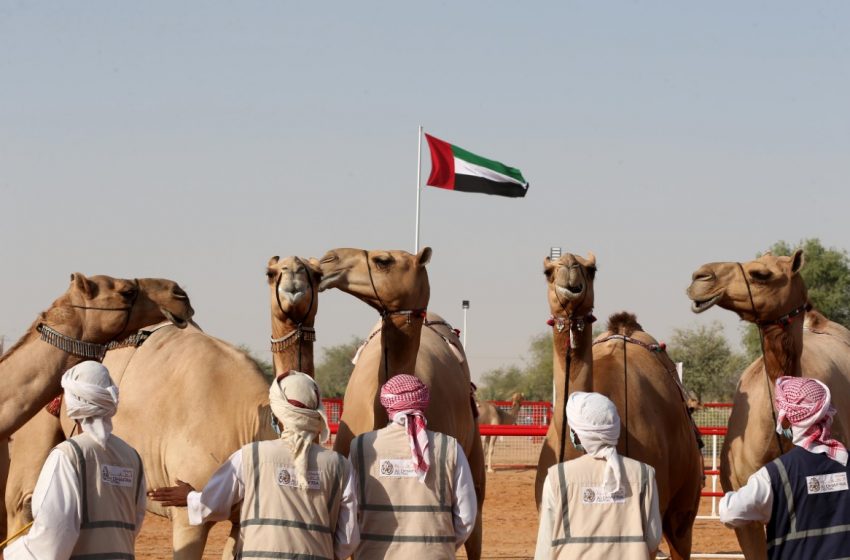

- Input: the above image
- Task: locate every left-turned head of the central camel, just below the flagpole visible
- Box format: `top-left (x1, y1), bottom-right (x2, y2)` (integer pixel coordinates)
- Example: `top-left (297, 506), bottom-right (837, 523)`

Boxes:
top-left (319, 247), bottom-right (431, 311)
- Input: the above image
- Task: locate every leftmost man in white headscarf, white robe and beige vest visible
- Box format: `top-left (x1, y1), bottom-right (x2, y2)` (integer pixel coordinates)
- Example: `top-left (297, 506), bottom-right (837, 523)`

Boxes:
top-left (4, 361), bottom-right (145, 560)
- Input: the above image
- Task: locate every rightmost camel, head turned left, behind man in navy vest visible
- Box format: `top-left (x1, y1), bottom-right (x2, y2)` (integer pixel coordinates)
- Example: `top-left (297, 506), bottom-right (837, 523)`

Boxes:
top-left (688, 251), bottom-right (850, 558)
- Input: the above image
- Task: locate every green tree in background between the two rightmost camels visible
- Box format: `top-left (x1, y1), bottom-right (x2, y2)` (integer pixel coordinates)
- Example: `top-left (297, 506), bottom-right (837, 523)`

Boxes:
top-left (668, 322), bottom-right (748, 402)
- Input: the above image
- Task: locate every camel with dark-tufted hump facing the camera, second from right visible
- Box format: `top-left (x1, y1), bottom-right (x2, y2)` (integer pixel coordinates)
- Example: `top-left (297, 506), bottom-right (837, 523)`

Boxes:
top-left (536, 254), bottom-right (703, 559)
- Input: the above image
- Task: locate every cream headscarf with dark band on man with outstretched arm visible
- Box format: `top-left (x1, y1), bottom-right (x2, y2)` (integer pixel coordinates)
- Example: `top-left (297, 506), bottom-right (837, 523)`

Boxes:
top-left (269, 371), bottom-right (330, 488)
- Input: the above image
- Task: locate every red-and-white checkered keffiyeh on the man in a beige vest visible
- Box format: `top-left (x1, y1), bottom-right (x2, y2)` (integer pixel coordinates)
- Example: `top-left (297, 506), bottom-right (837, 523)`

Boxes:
top-left (381, 374), bottom-right (431, 482)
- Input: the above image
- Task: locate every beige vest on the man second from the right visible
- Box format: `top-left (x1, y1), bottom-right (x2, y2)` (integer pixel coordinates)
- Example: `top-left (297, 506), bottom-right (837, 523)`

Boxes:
top-left (548, 455), bottom-right (655, 560)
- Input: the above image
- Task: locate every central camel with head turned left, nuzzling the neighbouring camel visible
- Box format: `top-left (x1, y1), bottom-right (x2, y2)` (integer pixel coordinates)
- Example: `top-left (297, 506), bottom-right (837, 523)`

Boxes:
top-left (319, 247), bottom-right (485, 560)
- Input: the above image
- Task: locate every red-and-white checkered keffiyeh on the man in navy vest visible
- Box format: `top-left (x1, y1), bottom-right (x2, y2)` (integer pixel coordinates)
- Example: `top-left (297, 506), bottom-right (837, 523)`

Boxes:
top-left (775, 377), bottom-right (848, 465)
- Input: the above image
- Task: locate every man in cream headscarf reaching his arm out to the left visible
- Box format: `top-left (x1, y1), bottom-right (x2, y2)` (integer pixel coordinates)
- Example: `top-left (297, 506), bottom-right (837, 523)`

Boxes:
top-left (149, 371), bottom-right (360, 559)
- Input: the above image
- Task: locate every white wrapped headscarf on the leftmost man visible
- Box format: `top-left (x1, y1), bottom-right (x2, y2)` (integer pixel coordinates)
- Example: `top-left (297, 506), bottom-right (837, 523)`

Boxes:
top-left (62, 361), bottom-right (118, 447)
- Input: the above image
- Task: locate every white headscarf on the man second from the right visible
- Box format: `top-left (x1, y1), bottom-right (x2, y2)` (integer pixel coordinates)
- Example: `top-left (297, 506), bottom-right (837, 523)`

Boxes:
top-left (566, 392), bottom-right (623, 492)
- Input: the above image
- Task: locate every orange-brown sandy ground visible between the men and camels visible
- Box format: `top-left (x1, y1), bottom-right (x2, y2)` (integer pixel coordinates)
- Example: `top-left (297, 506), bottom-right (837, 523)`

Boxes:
top-left (136, 469), bottom-right (740, 560)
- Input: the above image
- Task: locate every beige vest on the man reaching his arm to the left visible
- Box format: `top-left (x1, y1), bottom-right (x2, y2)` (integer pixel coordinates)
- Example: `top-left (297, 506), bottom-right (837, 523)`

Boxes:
top-left (237, 440), bottom-right (350, 560)
